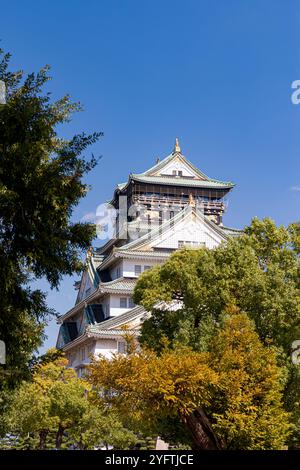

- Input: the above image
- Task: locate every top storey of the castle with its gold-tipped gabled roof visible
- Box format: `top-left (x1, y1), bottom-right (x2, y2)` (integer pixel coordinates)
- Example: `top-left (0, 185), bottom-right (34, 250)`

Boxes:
top-left (111, 138), bottom-right (234, 239)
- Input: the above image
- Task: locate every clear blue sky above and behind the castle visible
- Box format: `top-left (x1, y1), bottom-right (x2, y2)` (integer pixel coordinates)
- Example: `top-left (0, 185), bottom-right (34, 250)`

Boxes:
top-left (0, 0), bottom-right (300, 349)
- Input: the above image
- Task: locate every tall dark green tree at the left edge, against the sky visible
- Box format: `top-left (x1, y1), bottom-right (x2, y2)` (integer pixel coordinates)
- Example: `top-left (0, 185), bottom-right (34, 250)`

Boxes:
top-left (0, 50), bottom-right (101, 389)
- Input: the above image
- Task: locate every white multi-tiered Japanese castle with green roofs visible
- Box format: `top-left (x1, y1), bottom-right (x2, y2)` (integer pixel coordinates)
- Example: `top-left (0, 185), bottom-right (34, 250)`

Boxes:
top-left (57, 139), bottom-right (240, 377)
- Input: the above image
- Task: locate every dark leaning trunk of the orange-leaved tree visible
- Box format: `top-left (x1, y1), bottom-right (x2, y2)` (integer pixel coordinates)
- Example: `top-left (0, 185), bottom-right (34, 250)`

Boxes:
top-left (181, 407), bottom-right (222, 450)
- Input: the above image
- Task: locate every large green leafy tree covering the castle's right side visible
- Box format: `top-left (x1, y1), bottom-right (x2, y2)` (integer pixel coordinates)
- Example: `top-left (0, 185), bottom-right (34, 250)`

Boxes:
top-left (134, 219), bottom-right (300, 443)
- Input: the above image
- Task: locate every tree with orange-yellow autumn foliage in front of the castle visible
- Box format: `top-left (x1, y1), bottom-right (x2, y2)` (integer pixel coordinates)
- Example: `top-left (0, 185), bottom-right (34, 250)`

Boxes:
top-left (88, 313), bottom-right (290, 450)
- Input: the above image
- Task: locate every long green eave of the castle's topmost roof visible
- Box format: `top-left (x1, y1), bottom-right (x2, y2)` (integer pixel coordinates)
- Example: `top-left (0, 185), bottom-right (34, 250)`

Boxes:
top-left (131, 174), bottom-right (234, 189)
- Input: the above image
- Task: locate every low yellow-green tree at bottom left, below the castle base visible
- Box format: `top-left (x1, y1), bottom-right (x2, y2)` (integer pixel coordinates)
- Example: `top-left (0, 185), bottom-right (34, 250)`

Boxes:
top-left (2, 350), bottom-right (136, 450)
